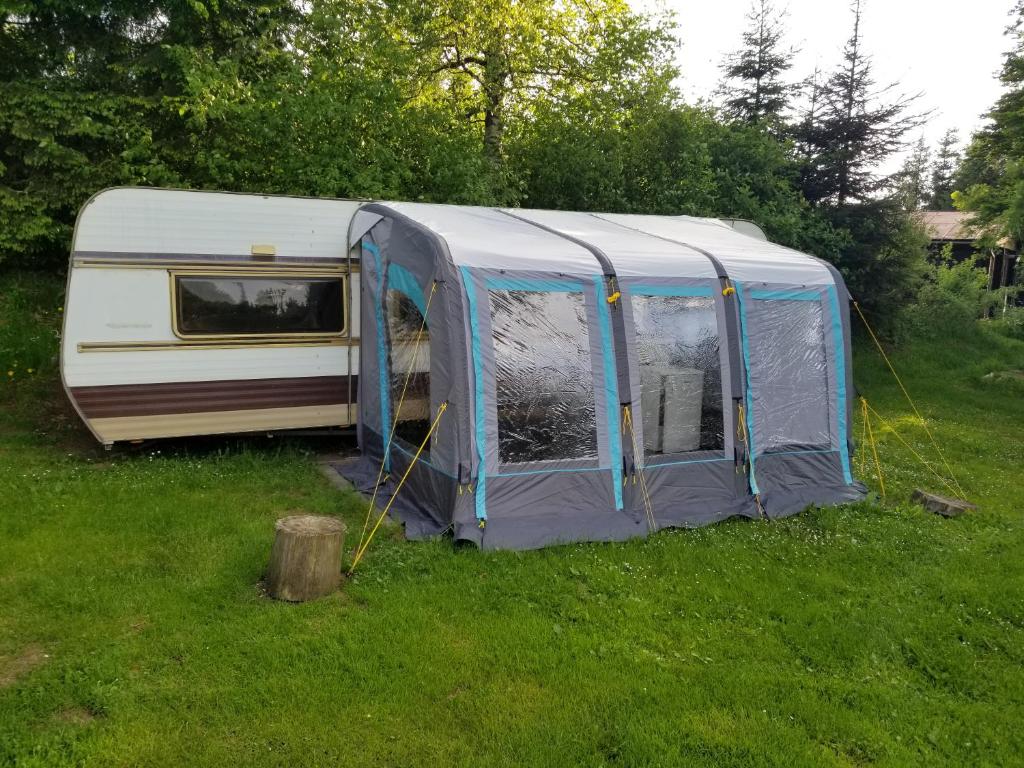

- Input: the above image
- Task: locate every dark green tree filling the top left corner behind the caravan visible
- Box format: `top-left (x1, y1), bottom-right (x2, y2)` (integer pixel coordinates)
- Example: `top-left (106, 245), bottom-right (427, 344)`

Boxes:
top-left (0, 0), bottom-right (300, 264)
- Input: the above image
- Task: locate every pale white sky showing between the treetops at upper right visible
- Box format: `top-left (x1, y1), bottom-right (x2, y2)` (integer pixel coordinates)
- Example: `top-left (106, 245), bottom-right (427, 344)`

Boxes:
top-left (633, 0), bottom-right (1014, 165)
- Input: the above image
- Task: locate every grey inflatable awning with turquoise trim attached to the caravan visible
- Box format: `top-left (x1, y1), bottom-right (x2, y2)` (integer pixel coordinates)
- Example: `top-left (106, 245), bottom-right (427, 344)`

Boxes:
top-left (337, 203), bottom-right (864, 549)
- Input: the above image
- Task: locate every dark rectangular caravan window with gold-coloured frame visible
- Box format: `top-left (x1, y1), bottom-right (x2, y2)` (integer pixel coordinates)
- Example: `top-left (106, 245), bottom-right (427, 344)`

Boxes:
top-left (174, 274), bottom-right (345, 336)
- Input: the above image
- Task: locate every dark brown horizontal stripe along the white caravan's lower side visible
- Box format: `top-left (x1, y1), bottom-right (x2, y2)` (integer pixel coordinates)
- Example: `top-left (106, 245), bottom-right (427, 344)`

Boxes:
top-left (71, 376), bottom-right (358, 419)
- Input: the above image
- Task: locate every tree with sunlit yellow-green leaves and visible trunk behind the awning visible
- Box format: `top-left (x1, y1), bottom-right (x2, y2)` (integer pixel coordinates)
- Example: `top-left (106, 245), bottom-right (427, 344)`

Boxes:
top-left (388, 0), bottom-right (675, 203)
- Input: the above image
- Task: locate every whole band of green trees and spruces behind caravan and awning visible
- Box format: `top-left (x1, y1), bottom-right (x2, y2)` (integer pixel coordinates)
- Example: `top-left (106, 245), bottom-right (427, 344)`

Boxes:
top-left (0, 0), bottom-right (942, 331)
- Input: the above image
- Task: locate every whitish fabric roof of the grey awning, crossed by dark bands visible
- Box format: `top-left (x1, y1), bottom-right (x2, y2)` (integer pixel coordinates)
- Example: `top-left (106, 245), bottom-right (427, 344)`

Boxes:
top-left (381, 203), bottom-right (834, 285)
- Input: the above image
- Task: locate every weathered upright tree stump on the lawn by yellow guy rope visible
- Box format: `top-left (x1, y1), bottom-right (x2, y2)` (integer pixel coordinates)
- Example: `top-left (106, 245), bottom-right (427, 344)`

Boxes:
top-left (266, 515), bottom-right (345, 602)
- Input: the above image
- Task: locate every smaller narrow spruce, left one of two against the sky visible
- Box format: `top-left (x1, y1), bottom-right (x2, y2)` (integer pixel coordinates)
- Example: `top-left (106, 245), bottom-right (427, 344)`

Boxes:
top-left (721, 0), bottom-right (795, 134)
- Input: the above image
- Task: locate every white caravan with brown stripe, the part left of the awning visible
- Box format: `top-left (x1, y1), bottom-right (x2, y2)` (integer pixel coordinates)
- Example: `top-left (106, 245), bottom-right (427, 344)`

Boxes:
top-left (60, 187), bottom-right (359, 444)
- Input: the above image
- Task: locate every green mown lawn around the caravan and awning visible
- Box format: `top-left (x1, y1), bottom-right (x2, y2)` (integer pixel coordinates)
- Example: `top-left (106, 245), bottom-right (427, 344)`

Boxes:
top-left (0, 268), bottom-right (1024, 768)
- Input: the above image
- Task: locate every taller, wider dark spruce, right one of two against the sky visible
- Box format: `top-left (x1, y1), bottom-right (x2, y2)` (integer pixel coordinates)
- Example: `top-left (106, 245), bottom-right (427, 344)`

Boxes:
top-left (796, 0), bottom-right (924, 206)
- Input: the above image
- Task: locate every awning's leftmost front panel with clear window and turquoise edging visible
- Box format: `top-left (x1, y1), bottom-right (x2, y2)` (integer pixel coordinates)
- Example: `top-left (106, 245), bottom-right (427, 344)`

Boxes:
top-left (462, 267), bottom-right (622, 524)
